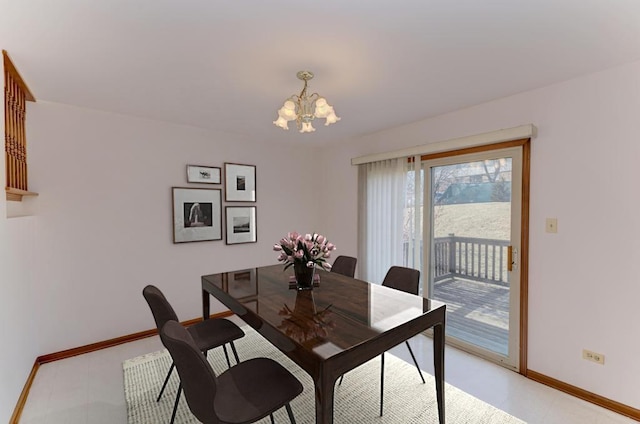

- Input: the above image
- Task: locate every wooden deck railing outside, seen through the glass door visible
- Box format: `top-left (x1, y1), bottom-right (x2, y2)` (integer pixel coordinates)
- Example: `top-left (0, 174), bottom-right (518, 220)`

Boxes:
top-left (404, 234), bottom-right (509, 286)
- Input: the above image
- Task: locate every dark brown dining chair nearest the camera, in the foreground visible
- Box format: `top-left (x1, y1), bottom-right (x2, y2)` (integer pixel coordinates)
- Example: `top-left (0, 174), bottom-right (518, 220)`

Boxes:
top-left (160, 321), bottom-right (302, 424)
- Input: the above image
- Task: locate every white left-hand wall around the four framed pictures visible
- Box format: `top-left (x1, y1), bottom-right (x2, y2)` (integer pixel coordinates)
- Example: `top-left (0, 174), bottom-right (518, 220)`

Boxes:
top-left (0, 98), bottom-right (319, 421)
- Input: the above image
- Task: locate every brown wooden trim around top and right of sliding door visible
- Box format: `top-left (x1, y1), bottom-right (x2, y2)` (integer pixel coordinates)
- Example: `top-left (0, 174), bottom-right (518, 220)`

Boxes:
top-left (421, 138), bottom-right (531, 376)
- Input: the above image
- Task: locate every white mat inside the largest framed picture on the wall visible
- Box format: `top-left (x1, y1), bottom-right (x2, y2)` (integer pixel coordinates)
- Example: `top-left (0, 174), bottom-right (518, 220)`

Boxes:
top-left (173, 187), bottom-right (222, 243)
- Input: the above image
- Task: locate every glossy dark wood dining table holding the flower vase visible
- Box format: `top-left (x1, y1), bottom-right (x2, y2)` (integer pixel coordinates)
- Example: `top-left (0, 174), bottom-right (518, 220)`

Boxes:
top-left (201, 265), bottom-right (446, 424)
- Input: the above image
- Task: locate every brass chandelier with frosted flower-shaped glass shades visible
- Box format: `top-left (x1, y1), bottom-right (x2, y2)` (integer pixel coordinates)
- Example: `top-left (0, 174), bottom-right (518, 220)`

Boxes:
top-left (273, 71), bottom-right (340, 133)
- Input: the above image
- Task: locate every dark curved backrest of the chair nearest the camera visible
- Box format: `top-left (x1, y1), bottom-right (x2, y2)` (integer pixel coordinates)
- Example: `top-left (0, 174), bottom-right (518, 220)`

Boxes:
top-left (160, 320), bottom-right (220, 424)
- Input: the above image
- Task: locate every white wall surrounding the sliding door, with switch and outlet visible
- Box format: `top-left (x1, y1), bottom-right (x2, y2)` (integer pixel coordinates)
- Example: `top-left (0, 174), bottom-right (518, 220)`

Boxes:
top-left (324, 62), bottom-right (640, 408)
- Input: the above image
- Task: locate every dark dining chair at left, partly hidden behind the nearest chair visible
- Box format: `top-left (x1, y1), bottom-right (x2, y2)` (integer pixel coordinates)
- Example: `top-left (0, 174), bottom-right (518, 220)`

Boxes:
top-left (142, 285), bottom-right (244, 423)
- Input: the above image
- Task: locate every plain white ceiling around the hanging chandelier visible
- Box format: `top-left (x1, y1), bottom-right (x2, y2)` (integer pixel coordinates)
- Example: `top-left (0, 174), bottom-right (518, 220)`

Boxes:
top-left (0, 0), bottom-right (640, 144)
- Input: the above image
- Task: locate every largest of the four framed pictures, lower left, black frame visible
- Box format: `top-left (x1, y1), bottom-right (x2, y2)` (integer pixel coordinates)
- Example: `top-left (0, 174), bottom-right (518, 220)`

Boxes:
top-left (172, 187), bottom-right (222, 243)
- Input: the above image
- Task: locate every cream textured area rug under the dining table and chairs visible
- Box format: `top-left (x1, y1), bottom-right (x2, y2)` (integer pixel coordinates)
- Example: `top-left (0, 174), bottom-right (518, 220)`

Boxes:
top-left (122, 326), bottom-right (524, 424)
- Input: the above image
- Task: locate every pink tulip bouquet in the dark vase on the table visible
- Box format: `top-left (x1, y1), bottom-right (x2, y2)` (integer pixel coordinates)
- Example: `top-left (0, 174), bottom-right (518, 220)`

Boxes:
top-left (273, 231), bottom-right (336, 270)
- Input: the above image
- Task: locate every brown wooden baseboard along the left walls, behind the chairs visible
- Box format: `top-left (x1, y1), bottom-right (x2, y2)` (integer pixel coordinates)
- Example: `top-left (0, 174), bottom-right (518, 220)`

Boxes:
top-left (9, 311), bottom-right (233, 424)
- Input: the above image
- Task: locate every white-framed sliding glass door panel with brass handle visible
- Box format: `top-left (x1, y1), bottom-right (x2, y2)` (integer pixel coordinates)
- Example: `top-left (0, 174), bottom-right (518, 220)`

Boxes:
top-left (422, 147), bottom-right (522, 368)
